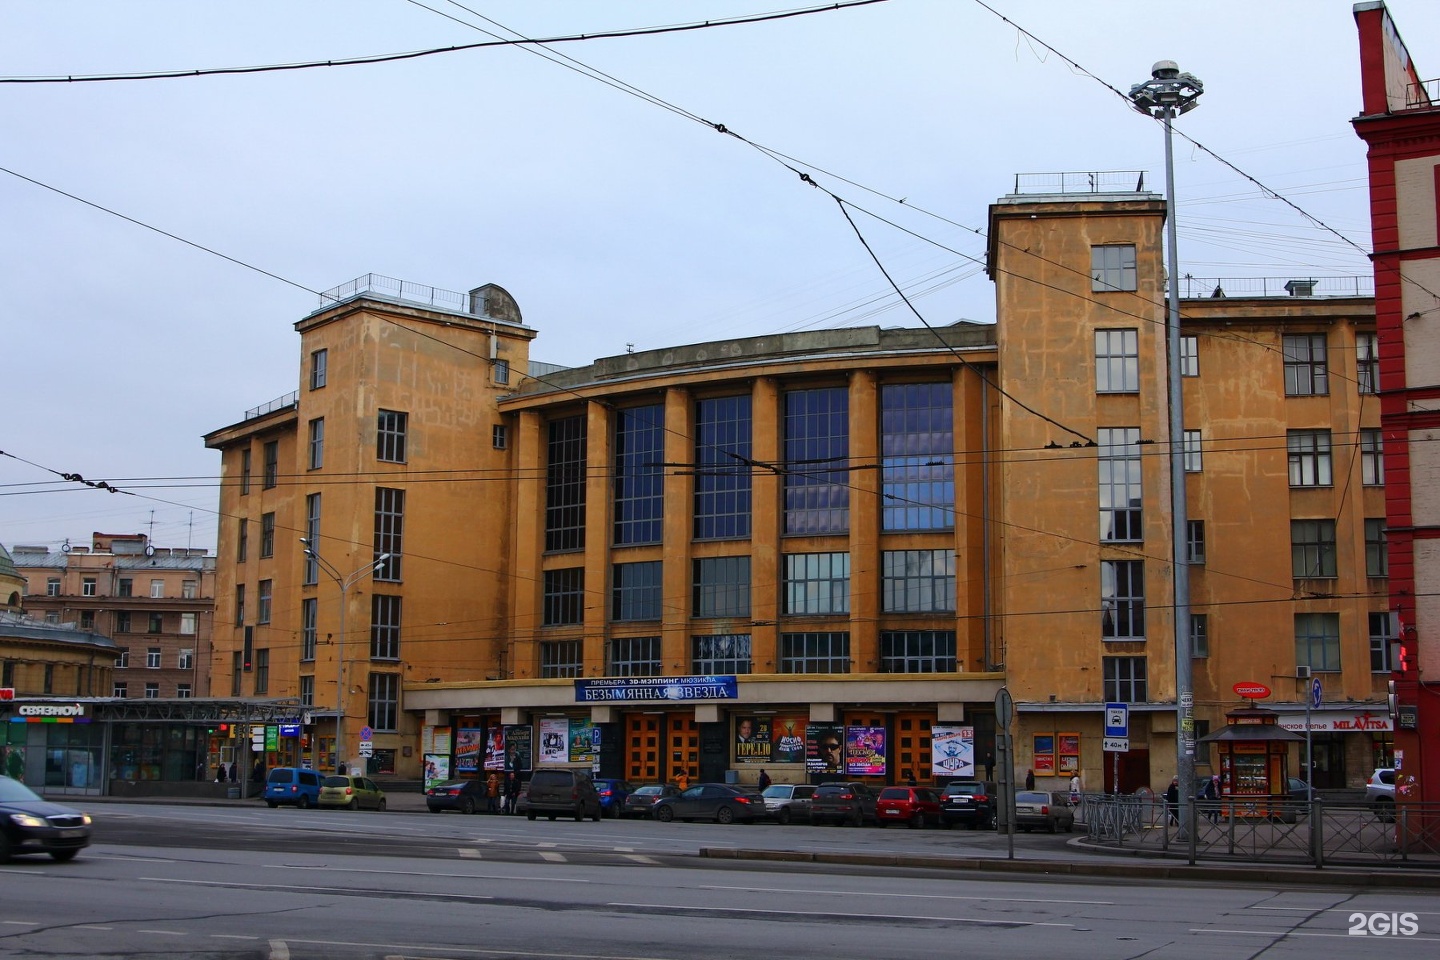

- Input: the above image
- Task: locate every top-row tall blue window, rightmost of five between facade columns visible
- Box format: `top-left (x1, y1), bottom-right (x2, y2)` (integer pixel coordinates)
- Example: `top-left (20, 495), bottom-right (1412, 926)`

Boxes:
top-left (875, 381), bottom-right (955, 531)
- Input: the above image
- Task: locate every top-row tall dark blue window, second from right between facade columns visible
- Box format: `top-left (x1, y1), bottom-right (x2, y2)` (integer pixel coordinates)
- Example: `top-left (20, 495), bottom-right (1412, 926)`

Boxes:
top-left (785, 387), bottom-right (850, 534)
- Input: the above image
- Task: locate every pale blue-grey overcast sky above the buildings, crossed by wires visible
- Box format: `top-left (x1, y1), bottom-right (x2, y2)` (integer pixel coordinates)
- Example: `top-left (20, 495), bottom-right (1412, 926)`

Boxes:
top-left (0, 0), bottom-right (1440, 548)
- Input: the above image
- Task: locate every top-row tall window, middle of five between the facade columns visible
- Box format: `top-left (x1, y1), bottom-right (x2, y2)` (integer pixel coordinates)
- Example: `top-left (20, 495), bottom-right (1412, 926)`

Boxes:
top-left (694, 396), bottom-right (750, 540)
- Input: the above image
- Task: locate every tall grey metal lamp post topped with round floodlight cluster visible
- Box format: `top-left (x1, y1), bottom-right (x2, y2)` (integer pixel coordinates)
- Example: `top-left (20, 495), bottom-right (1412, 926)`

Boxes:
top-left (1130, 60), bottom-right (1205, 830)
